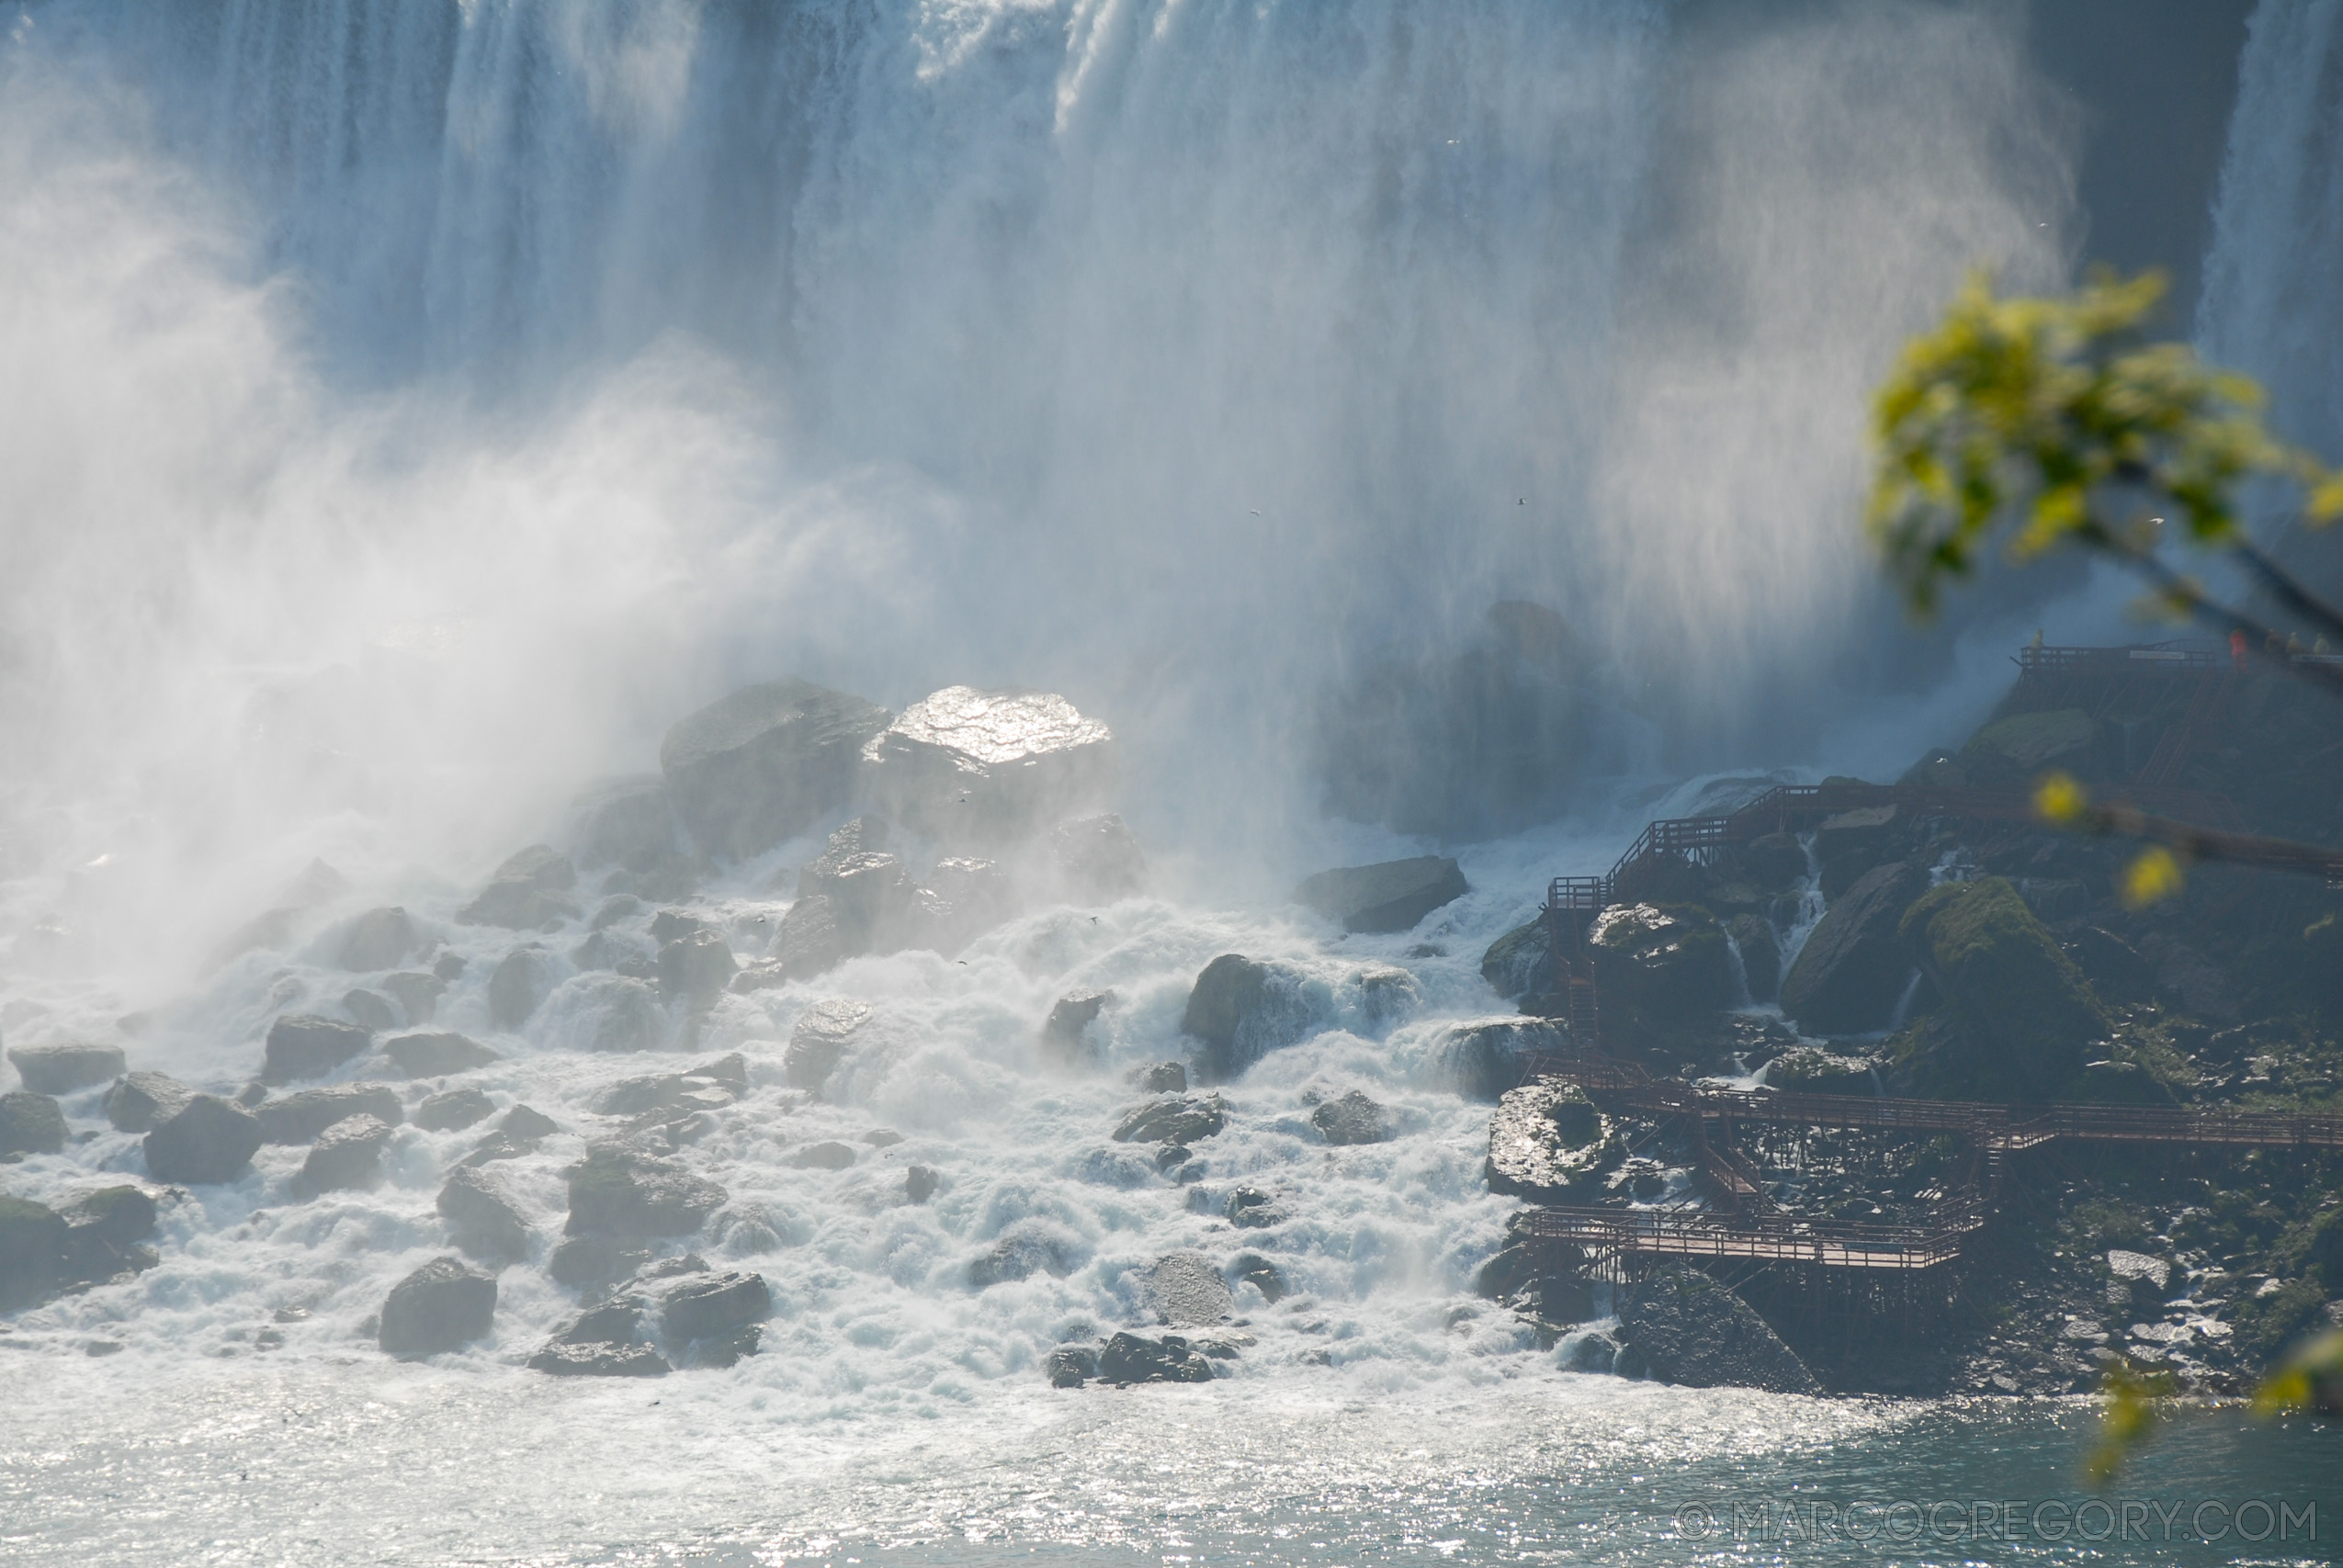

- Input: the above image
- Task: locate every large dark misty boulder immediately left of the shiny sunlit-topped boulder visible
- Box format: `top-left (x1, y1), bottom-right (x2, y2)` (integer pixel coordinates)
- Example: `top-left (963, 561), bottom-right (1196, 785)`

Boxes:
top-left (659, 680), bottom-right (888, 860)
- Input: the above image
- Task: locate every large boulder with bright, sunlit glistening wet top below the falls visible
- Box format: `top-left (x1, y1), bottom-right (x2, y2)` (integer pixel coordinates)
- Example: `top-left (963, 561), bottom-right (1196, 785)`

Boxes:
top-left (862, 687), bottom-right (1115, 844)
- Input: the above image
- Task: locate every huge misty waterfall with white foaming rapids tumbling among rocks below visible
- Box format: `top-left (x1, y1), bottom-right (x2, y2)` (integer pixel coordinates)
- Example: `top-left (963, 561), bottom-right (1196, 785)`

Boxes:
top-left (0, 0), bottom-right (2324, 1563)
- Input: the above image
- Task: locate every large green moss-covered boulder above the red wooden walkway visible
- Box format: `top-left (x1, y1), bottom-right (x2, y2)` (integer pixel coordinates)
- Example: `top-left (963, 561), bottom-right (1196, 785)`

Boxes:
top-left (1900, 876), bottom-right (2109, 1100)
